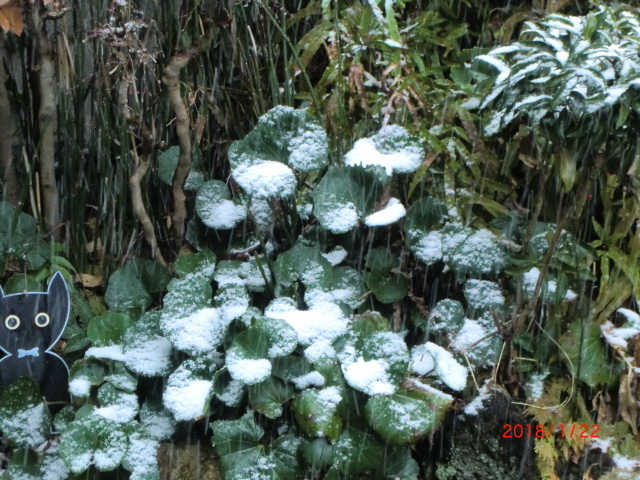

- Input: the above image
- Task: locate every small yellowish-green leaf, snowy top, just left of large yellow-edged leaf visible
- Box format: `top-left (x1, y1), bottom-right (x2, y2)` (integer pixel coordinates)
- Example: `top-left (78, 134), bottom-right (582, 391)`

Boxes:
top-left (292, 387), bottom-right (342, 442)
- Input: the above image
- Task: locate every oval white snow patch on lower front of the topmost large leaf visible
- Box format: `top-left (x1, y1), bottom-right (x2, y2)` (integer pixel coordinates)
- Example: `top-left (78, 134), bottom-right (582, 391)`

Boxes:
top-left (232, 160), bottom-right (296, 198)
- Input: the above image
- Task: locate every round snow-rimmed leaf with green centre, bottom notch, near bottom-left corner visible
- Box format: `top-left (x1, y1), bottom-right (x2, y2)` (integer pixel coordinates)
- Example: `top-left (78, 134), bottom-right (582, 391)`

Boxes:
top-left (59, 415), bottom-right (128, 473)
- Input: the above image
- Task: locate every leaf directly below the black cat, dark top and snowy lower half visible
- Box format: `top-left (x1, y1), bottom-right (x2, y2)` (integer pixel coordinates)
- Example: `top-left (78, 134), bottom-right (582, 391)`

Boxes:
top-left (0, 377), bottom-right (51, 448)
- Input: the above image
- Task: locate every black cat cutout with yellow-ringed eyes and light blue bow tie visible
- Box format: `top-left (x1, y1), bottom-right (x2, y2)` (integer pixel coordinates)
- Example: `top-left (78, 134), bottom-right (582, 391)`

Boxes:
top-left (0, 272), bottom-right (71, 402)
